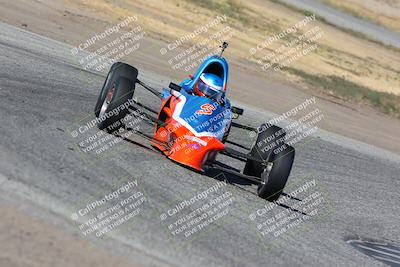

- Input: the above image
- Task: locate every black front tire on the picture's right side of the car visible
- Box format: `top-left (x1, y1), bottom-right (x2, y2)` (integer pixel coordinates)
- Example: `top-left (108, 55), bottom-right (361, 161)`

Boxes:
top-left (257, 147), bottom-right (295, 201)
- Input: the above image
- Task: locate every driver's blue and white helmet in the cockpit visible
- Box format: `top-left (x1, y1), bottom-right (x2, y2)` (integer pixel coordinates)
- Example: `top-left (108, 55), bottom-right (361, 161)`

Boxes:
top-left (194, 73), bottom-right (224, 99)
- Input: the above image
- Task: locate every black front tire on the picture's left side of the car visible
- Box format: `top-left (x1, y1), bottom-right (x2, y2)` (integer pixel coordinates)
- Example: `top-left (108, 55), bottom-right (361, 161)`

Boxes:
top-left (97, 77), bottom-right (135, 132)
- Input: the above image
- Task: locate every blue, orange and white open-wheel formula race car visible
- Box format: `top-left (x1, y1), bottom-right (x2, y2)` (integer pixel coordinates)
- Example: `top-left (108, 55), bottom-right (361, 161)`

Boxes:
top-left (95, 43), bottom-right (295, 201)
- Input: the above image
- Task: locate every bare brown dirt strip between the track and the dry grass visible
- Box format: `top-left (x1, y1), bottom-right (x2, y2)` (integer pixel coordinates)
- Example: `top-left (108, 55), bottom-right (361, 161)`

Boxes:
top-left (0, 0), bottom-right (400, 157)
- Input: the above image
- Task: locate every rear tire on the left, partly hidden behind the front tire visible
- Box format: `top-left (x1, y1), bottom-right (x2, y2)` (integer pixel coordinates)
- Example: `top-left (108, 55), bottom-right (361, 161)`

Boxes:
top-left (94, 62), bottom-right (138, 118)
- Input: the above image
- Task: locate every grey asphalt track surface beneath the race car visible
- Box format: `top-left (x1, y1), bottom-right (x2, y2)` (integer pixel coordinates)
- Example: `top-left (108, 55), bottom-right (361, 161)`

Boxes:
top-left (0, 24), bottom-right (400, 266)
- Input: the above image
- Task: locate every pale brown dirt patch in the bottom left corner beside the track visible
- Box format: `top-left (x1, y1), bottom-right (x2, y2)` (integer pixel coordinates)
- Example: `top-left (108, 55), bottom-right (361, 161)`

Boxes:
top-left (0, 205), bottom-right (137, 267)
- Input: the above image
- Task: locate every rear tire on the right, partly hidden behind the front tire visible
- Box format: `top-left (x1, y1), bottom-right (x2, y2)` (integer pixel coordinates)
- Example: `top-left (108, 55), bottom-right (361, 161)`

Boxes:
top-left (243, 124), bottom-right (286, 177)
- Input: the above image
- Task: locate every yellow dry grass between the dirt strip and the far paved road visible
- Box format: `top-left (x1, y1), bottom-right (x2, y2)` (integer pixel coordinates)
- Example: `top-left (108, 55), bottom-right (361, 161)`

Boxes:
top-left (69, 0), bottom-right (400, 114)
